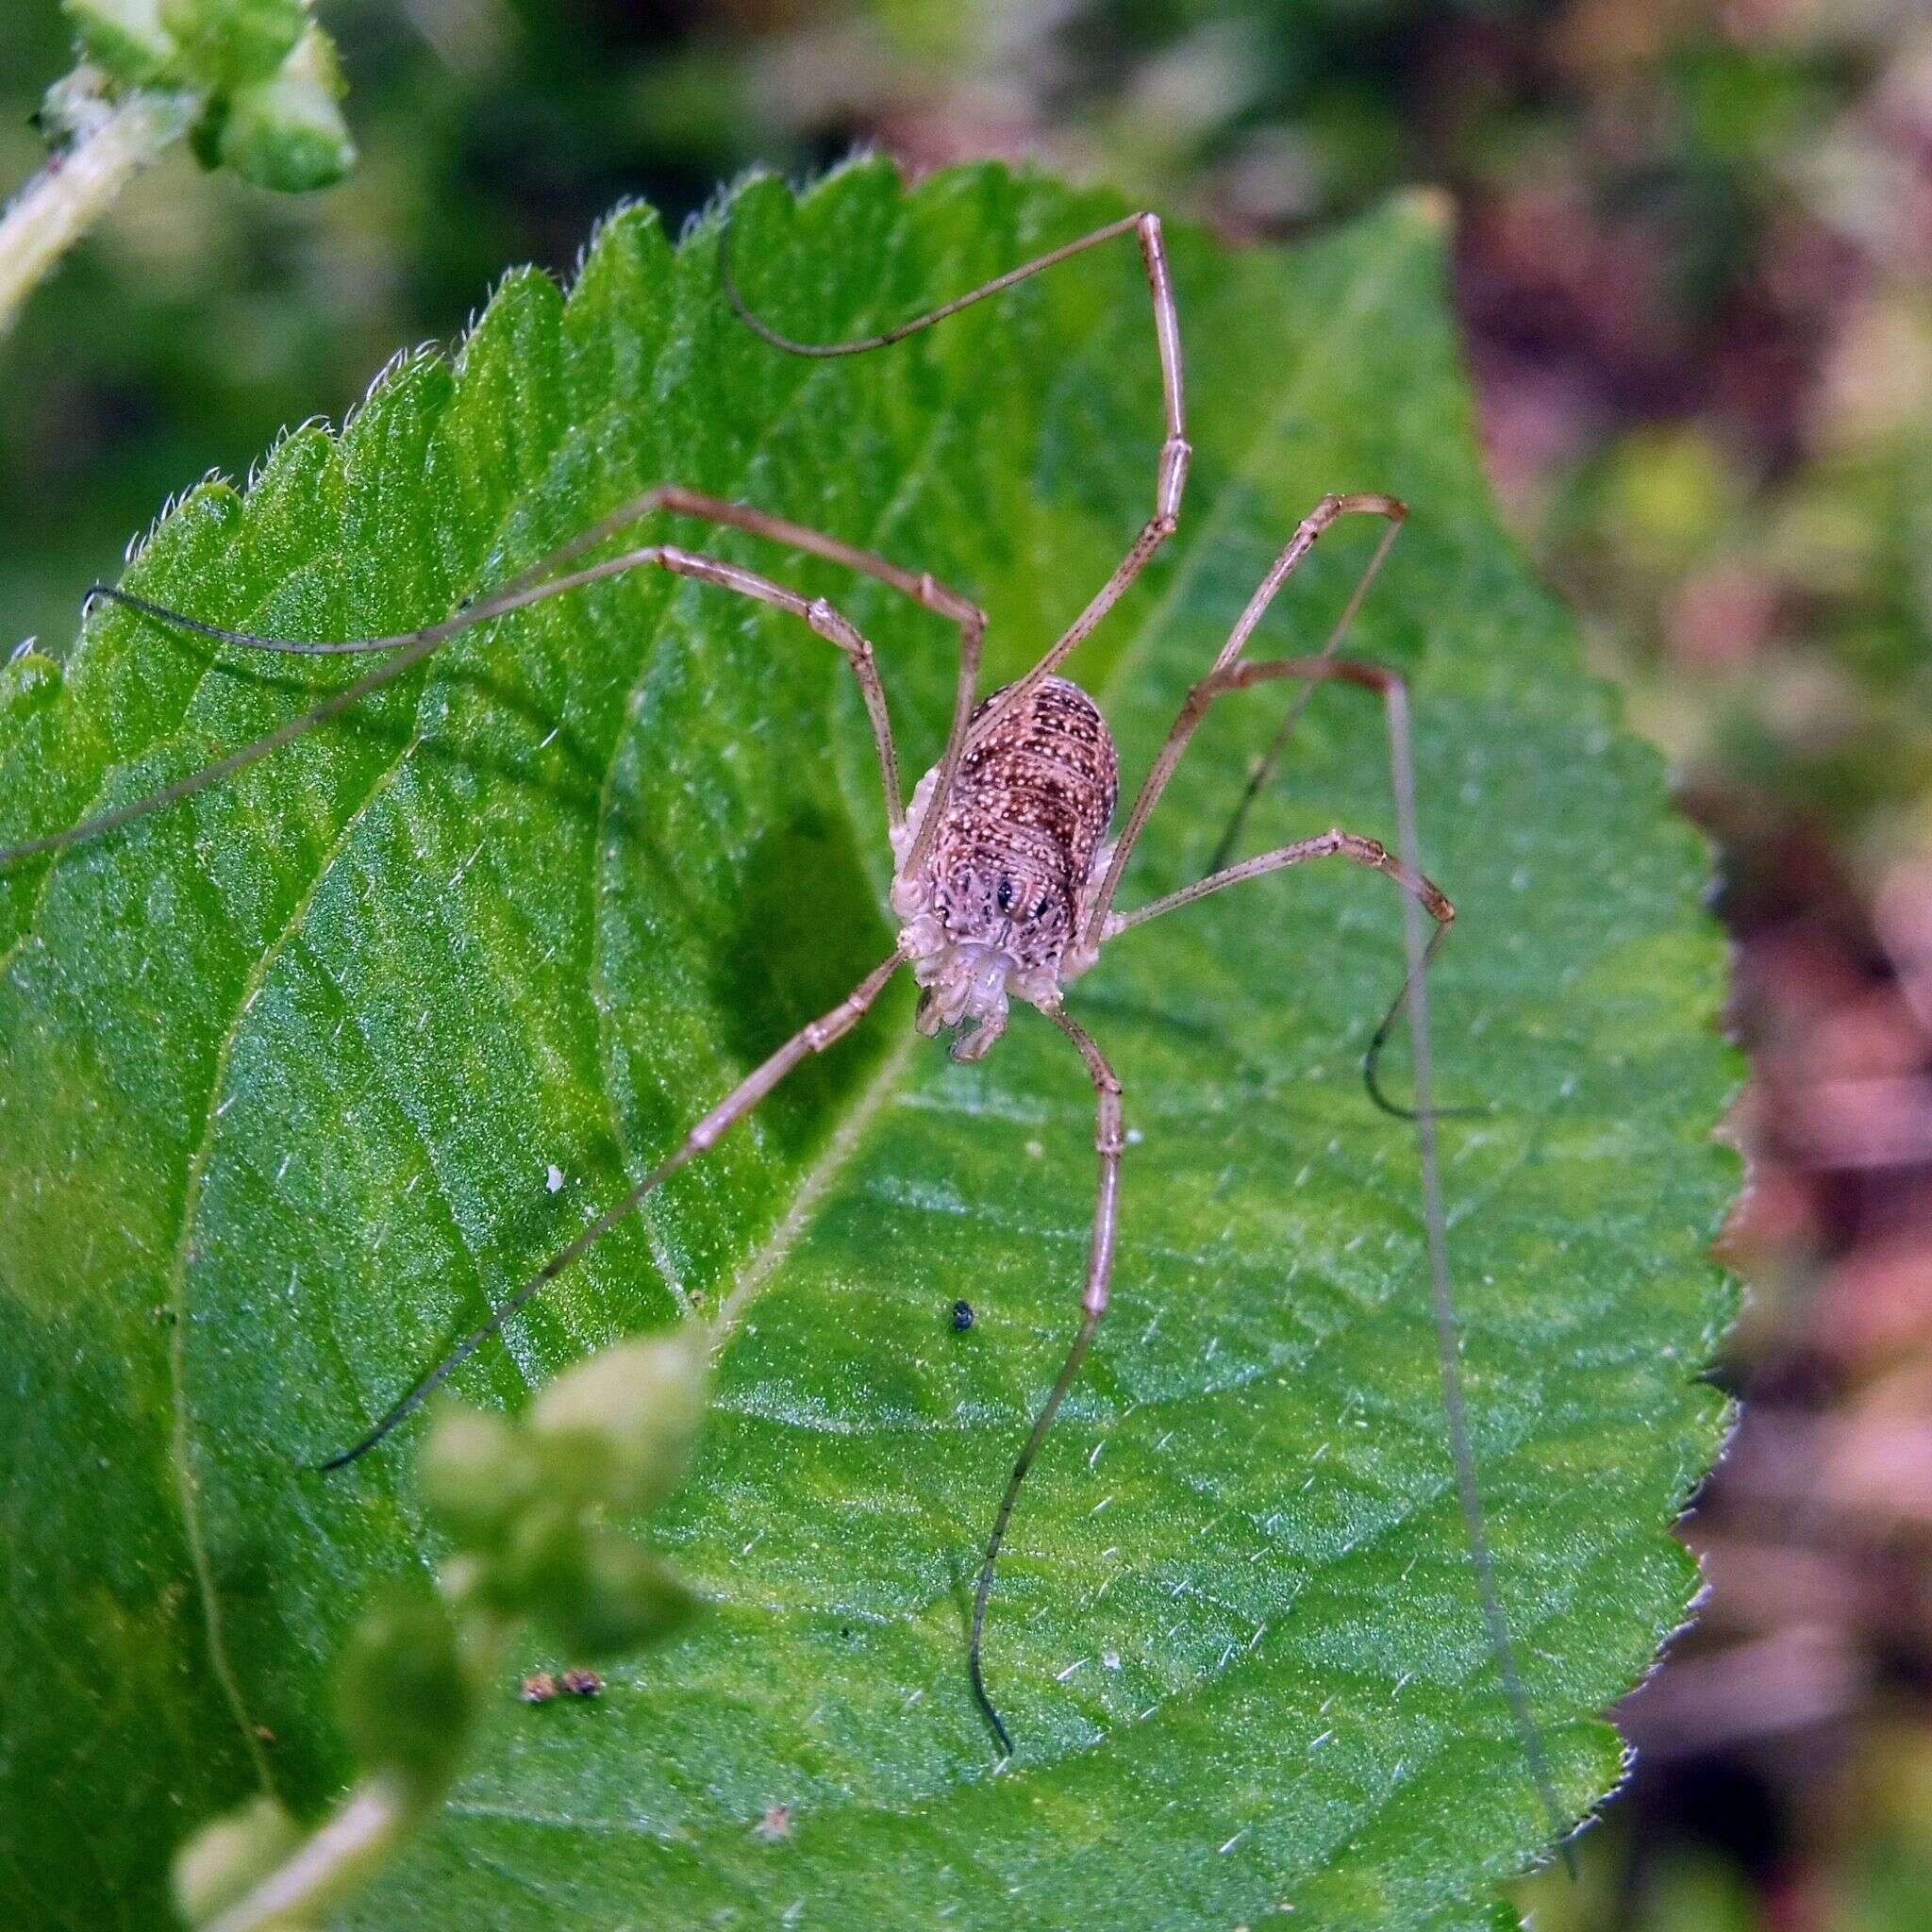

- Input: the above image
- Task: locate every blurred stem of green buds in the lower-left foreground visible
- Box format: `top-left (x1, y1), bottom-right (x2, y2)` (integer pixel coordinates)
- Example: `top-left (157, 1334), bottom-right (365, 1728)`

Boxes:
top-left (170, 1327), bottom-right (708, 1932)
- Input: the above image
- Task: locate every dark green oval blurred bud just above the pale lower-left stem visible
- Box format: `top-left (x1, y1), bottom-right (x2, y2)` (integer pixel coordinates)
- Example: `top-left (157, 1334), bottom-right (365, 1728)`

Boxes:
top-left (336, 1588), bottom-right (475, 1785)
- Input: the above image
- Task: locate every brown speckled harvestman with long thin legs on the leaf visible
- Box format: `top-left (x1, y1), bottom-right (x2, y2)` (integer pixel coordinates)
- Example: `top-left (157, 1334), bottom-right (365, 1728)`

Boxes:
top-left (0, 204), bottom-right (1565, 1838)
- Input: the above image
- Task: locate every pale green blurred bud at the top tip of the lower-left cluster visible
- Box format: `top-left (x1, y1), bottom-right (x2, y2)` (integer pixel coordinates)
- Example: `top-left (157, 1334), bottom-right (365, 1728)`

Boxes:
top-left (529, 1325), bottom-right (706, 1511)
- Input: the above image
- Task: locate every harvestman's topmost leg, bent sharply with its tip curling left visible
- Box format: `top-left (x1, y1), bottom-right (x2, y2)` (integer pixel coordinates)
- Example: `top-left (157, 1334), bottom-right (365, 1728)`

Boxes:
top-left (719, 197), bottom-right (1192, 874)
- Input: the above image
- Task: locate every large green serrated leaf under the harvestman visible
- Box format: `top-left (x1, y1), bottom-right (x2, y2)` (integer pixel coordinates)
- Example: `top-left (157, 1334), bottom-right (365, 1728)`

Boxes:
top-left (0, 166), bottom-right (1733, 1928)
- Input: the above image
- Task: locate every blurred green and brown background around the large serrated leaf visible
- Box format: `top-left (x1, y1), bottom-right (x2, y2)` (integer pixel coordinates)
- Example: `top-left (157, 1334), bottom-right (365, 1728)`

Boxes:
top-left (0, 0), bottom-right (1932, 1932)
